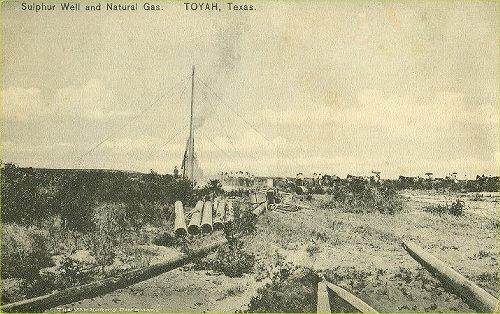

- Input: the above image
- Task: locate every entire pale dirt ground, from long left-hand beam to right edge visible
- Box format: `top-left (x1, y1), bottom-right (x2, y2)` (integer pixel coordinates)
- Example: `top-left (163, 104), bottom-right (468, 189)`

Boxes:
top-left (50, 191), bottom-right (500, 312)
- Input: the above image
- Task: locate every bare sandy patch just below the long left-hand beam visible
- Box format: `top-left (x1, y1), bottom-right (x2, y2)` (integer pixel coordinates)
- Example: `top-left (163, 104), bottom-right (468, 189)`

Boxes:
top-left (48, 268), bottom-right (264, 312)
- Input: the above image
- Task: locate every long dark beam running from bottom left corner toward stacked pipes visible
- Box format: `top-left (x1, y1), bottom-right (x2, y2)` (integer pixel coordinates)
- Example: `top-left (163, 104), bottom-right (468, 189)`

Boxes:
top-left (0, 239), bottom-right (227, 312)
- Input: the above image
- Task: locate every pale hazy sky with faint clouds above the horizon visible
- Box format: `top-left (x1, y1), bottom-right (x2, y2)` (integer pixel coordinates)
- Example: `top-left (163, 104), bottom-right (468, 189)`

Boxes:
top-left (2, 1), bottom-right (500, 178)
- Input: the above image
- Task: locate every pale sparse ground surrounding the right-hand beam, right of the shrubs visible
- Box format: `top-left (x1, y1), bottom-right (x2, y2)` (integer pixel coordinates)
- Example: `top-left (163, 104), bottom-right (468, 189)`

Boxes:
top-left (248, 191), bottom-right (499, 312)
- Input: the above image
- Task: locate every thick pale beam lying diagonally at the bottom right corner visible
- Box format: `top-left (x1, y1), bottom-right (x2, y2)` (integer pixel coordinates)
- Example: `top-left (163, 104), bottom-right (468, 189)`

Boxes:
top-left (402, 241), bottom-right (499, 312)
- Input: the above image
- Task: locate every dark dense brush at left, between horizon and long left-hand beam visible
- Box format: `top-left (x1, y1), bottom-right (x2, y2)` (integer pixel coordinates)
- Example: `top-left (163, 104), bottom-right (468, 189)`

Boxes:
top-left (0, 163), bottom-right (222, 302)
